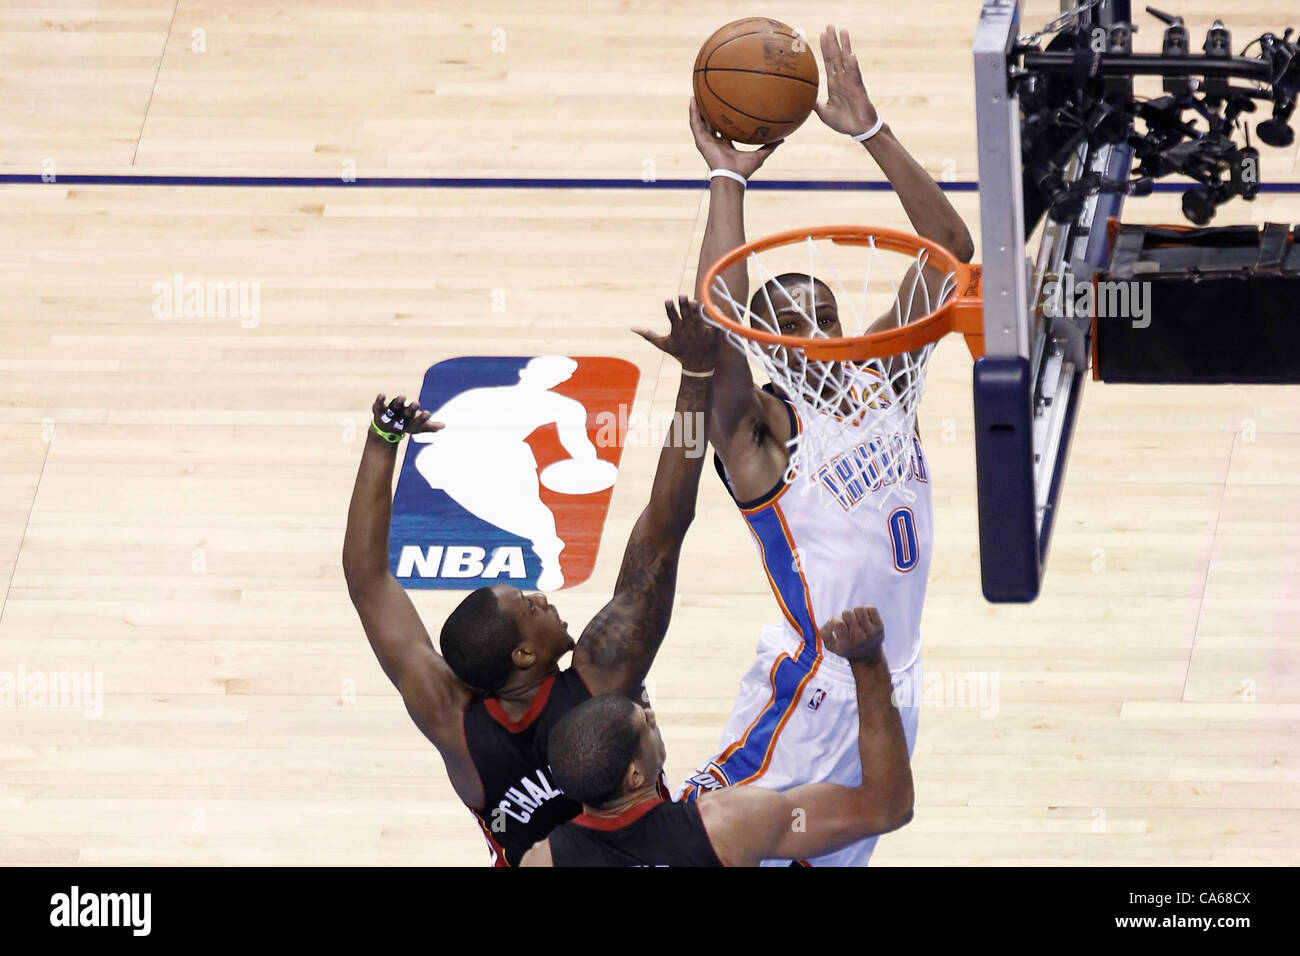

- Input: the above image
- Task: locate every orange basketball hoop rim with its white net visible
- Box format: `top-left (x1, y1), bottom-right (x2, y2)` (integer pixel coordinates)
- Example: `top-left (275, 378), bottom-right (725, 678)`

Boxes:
top-left (701, 226), bottom-right (984, 511)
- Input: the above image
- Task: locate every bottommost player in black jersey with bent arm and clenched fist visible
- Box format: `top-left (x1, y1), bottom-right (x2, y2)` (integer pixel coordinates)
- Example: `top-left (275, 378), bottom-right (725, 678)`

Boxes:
top-left (523, 607), bottom-right (913, 866)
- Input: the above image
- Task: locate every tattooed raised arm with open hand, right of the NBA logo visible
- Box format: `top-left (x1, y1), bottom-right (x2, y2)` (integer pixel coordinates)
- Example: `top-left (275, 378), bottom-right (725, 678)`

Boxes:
top-left (573, 297), bottom-right (719, 695)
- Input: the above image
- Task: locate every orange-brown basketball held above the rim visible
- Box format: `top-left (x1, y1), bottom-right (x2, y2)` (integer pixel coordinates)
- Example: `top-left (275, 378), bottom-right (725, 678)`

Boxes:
top-left (693, 17), bottom-right (818, 146)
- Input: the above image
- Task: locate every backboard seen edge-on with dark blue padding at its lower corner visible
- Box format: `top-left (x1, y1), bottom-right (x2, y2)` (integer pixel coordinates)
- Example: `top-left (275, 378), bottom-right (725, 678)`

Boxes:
top-left (974, 0), bottom-right (1131, 602)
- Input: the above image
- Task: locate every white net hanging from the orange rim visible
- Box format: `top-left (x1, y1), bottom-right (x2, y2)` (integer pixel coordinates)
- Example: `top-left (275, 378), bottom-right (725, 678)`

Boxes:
top-left (712, 235), bottom-right (957, 511)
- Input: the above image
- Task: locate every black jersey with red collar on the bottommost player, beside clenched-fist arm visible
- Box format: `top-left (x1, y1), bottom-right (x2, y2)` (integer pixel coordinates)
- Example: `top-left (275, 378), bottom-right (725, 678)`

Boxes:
top-left (550, 797), bottom-right (723, 866)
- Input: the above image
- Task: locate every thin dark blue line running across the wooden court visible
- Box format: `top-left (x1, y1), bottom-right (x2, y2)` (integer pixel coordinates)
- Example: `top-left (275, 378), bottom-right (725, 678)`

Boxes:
top-left (0, 173), bottom-right (1300, 193)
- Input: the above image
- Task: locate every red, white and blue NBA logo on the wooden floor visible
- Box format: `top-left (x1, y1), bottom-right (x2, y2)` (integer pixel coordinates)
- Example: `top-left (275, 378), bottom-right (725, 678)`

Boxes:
top-left (389, 355), bottom-right (638, 591)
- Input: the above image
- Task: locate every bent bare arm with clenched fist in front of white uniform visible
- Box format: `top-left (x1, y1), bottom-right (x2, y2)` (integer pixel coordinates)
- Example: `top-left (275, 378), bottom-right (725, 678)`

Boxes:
top-left (699, 607), bottom-right (913, 866)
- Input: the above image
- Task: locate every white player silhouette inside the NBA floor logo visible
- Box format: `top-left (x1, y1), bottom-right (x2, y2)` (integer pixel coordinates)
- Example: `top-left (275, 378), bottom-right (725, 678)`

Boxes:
top-left (411, 355), bottom-right (619, 591)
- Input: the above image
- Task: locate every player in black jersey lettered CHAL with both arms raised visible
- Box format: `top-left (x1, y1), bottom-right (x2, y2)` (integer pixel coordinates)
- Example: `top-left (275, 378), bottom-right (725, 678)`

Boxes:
top-left (343, 297), bottom-right (719, 866)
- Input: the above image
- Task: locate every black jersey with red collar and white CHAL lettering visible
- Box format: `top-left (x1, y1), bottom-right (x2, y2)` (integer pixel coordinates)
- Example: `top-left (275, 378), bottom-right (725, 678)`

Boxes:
top-left (465, 667), bottom-right (592, 866)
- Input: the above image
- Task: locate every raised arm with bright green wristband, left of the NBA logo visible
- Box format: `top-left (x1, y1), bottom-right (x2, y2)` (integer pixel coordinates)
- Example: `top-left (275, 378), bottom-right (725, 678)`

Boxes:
top-left (343, 395), bottom-right (482, 806)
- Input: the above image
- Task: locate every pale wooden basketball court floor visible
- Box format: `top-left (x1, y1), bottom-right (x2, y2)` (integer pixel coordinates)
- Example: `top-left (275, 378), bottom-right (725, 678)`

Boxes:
top-left (0, 0), bottom-right (1300, 865)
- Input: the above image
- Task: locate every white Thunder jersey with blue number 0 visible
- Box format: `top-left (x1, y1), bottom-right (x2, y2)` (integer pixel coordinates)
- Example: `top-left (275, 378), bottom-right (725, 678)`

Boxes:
top-left (714, 385), bottom-right (933, 671)
